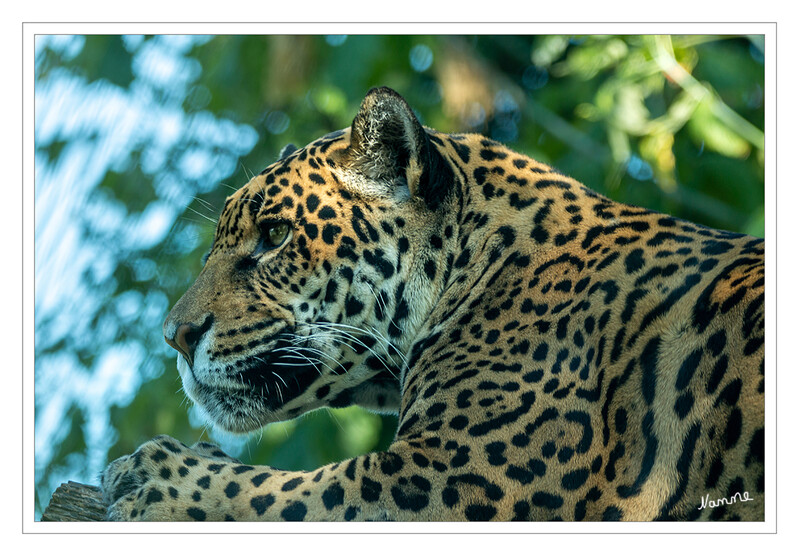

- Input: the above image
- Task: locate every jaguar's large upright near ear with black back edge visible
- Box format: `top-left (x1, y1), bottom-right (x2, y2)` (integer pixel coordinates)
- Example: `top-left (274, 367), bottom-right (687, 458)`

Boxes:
top-left (345, 87), bottom-right (451, 204)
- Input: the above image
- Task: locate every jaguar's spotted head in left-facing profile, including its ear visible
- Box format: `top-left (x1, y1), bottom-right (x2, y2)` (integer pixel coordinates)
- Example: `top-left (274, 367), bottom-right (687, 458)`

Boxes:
top-left (164, 88), bottom-right (455, 432)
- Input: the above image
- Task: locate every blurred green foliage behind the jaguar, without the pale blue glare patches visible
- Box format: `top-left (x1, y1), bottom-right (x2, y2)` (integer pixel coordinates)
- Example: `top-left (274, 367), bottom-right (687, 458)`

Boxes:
top-left (36, 35), bottom-right (765, 508)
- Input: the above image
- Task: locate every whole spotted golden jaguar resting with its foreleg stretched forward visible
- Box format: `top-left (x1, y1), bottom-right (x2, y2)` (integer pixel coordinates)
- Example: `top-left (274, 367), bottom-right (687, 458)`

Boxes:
top-left (101, 87), bottom-right (765, 521)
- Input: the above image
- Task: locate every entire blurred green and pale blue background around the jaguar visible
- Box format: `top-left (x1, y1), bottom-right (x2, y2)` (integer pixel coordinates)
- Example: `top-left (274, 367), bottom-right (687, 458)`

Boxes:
top-left (34, 35), bottom-right (765, 519)
